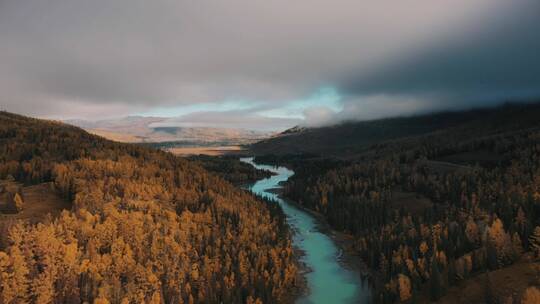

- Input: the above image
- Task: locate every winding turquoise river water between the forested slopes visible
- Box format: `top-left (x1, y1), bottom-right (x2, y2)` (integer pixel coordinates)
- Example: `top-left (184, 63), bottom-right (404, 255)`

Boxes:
top-left (241, 158), bottom-right (370, 304)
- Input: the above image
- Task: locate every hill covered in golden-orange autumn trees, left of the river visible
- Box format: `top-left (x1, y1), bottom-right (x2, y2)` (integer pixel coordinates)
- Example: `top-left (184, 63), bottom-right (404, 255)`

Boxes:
top-left (0, 112), bottom-right (296, 303)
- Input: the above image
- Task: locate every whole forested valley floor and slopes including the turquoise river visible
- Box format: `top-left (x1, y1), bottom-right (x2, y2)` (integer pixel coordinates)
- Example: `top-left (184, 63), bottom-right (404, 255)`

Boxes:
top-left (0, 103), bottom-right (540, 303)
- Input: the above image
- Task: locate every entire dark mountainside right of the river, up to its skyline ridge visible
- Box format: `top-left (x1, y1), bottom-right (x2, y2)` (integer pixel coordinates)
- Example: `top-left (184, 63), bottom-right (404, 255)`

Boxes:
top-left (252, 103), bottom-right (540, 303)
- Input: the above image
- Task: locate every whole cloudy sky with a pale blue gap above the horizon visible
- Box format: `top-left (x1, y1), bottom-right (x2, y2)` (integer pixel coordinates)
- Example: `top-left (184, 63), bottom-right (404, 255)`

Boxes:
top-left (0, 0), bottom-right (540, 130)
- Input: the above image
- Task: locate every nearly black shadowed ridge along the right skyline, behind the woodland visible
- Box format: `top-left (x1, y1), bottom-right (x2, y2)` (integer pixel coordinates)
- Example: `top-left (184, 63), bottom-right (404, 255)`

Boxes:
top-left (250, 104), bottom-right (540, 157)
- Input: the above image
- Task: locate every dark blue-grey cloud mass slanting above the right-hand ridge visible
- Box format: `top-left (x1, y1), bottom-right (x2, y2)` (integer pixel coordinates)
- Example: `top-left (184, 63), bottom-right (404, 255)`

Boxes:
top-left (340, 0), bottom-right (540, 123)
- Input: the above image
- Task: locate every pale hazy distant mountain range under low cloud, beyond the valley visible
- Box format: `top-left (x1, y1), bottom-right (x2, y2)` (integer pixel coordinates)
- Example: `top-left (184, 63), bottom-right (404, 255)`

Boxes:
top-left (65, 116), bottom-right (272, 145)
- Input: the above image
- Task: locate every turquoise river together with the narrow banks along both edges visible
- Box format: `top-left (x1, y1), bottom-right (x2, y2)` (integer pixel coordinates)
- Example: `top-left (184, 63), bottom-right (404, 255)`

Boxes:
top-left (241, 158), bottom-right (370, 304)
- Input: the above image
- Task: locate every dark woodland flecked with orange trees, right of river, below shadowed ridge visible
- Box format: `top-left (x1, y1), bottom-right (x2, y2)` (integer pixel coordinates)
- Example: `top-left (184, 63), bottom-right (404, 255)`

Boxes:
top-left (256, 105), bottom-right (540, 303)
